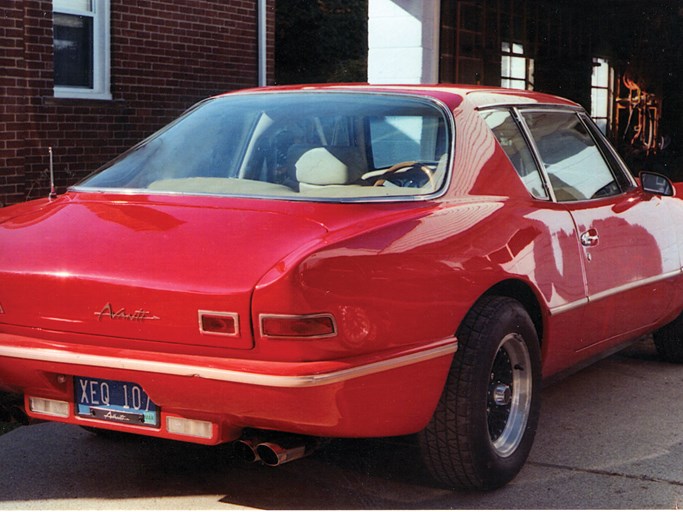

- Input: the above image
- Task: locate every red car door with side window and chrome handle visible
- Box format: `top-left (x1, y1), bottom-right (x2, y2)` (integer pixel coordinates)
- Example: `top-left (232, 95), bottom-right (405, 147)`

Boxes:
top-left (520, 109), bottom-right (681, 350)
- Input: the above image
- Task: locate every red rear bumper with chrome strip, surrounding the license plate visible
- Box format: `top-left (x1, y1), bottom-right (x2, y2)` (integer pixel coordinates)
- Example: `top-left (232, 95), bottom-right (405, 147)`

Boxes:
top-left (0, 334), bottom-right (457, 444)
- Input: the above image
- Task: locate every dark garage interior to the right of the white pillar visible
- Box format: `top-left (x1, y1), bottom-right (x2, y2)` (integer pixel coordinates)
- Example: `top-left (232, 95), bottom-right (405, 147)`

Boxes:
top-left (440, 0), bottom-right (683, 180)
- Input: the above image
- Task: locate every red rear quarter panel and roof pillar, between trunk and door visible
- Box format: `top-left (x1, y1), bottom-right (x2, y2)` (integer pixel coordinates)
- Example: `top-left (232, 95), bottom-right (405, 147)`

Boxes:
top-left (252, 98), bottom-right (585, 373)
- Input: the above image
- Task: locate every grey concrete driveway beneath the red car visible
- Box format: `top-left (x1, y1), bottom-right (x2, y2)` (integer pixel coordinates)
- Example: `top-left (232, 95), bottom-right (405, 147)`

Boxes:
top-left (0, 343), bottom-right (683, 509)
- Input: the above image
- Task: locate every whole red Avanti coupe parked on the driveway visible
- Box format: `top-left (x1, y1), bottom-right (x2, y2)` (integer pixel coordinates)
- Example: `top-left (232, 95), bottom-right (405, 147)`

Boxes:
top-left (0, 85), bottom-right (683, 489)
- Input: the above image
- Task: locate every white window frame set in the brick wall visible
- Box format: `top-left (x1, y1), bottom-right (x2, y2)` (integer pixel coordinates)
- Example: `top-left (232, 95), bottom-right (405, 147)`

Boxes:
top-left (52, 0), bottom-right (112, 100)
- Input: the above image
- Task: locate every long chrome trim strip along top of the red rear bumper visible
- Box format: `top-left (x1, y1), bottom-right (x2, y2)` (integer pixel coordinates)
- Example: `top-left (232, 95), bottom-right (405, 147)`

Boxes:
top-left (0, 338), bottom-right (458, 388)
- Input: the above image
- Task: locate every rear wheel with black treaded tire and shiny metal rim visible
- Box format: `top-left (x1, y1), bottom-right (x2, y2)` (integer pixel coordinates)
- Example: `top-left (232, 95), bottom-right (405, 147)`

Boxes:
top-left (418, 296), bottom-right (541, 490)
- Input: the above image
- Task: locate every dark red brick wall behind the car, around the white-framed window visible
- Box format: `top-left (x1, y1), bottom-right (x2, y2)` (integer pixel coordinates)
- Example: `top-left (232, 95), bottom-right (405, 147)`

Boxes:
top-left (0, 0), bottom-right (274, 204)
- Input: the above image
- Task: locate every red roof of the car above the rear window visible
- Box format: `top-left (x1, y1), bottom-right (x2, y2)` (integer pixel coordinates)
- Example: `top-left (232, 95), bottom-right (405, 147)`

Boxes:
top-left (227, 83), bottom-right (579, 109)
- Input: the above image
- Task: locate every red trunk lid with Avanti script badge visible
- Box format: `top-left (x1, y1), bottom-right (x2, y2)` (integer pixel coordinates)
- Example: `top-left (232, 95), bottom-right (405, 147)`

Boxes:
top-left (0, 194), bottom-right (327, 349)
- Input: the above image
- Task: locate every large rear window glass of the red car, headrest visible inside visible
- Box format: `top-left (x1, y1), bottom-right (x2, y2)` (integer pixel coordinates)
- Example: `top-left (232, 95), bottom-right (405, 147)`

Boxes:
top-left (77, 92), bottom-right (451, 199)
